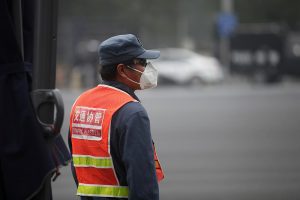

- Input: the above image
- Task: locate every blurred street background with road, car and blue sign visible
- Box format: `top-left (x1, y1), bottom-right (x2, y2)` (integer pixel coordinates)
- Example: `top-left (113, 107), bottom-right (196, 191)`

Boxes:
top-left (53, 0), bottom-right (300, 200)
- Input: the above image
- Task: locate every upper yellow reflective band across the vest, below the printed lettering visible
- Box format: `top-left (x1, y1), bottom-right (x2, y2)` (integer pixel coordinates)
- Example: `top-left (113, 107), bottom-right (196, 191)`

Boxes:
top-left (73, 155), bottom-right (113, 168)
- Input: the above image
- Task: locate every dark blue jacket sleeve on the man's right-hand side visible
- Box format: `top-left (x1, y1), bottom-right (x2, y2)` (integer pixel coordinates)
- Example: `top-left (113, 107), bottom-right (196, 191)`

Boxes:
top-left (120, 110), bottom-right (159, 200)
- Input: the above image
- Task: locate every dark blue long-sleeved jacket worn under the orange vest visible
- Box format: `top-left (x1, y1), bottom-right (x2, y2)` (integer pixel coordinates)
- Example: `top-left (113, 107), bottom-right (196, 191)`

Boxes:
top-left (69, 81), bottom-right (159, 200)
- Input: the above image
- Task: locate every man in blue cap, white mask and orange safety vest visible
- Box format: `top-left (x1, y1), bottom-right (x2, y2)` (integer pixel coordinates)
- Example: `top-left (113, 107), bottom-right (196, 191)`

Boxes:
top-left (69, 34), bottom-right (164, 200)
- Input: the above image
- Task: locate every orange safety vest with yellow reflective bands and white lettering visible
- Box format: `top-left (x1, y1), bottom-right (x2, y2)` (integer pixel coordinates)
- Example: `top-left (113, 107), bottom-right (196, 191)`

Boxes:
top-left (70, 85), bottom-right (164, 198)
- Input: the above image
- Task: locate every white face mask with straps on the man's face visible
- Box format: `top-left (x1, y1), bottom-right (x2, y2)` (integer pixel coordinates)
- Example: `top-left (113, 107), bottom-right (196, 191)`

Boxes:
top-left (127, 62), bottom-right (158, 90)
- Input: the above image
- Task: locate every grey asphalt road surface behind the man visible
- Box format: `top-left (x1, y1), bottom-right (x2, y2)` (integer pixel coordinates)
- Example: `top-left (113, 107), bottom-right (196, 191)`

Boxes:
top-left (52, 81), bottom-right (300, 200)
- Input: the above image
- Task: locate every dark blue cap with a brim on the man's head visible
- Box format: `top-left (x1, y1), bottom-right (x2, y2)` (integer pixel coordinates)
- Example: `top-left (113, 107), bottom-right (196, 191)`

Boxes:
top-left (98, 34), bottom-right (160, 66)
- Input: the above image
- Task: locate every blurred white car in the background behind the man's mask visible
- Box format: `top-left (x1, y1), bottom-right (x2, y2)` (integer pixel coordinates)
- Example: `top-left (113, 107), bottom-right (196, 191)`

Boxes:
top-left (153, 48), bottom-right (224, 84)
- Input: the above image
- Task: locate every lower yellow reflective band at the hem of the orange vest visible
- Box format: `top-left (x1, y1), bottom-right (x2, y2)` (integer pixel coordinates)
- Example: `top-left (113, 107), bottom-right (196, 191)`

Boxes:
top-left (77, 184), bottom-right (129, 198)
